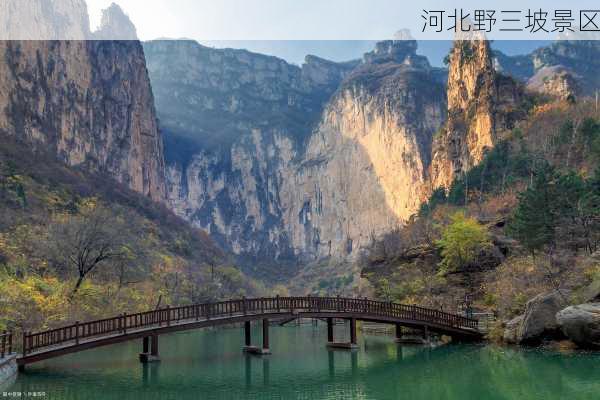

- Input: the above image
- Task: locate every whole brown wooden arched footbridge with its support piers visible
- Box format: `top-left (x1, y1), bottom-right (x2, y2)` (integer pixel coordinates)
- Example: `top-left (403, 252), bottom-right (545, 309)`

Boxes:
top-left (17, 297), bottom-right (483, 369)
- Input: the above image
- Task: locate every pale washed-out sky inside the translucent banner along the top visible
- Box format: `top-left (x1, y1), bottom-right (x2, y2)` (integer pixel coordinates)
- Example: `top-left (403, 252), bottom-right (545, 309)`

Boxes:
top-left (87, 0), bottom-right (600, 40)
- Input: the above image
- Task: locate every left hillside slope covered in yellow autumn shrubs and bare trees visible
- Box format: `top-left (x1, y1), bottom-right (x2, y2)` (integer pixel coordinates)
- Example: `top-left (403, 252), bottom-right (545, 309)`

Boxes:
top-left (0, 140), bottom-right (264, 330)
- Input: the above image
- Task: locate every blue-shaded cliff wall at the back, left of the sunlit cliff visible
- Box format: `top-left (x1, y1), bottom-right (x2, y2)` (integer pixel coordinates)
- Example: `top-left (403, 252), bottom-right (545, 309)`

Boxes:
top-left (145, 41), bottom-right (356, 260)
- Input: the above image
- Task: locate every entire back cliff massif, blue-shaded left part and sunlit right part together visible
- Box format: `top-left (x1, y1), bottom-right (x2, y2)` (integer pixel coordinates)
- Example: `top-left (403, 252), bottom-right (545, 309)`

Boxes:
top-left (145, 41), bottom-right (446, 260)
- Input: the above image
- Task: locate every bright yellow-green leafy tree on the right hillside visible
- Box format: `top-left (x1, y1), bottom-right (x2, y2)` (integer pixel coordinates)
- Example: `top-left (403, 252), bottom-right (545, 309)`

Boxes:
top-left (437, 212), bottom-right (491, 272)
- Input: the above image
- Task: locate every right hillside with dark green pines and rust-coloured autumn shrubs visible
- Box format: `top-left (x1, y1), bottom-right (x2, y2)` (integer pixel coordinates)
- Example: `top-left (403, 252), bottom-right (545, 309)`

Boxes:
top-left (363, 99), bottom-right (600, 319)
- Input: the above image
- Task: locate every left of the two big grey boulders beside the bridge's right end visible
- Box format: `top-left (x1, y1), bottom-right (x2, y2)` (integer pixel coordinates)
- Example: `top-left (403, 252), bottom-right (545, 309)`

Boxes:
top-left (517, 290), bottom-right (568, 344)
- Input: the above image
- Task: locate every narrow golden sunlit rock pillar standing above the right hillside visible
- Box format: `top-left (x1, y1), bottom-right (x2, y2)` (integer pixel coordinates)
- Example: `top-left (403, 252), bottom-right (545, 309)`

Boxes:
top-left (430, 38), bottom-right (521, 188)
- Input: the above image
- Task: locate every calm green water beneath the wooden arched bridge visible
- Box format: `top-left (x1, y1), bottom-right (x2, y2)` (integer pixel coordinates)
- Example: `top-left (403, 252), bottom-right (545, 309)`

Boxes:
top-left (7, 325), bottom-right (600, 400)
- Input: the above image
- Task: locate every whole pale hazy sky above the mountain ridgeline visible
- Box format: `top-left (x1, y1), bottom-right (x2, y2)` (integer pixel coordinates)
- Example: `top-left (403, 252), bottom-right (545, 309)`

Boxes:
top-left (86, 0), bottom-right (600, 65)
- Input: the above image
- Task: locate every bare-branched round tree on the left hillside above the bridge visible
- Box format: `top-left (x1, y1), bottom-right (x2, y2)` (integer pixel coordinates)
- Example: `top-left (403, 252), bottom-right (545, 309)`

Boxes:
top-left (48, 204), bottom-right (135, 294)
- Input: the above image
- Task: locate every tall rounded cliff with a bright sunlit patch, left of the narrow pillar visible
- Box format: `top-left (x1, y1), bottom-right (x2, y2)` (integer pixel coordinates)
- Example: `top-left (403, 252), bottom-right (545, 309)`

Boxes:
top-left (281, 41), bottom-right (446, 259)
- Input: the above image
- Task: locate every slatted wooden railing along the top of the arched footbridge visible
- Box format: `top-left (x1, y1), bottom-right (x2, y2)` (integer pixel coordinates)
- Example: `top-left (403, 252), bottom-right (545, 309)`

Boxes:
top-left (22, 296), bottom-right (477, 355)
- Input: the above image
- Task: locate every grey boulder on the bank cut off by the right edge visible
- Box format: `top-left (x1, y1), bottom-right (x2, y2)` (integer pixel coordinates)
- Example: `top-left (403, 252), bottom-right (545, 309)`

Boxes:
top-left (556, 303), bottom-right (600, 349)
